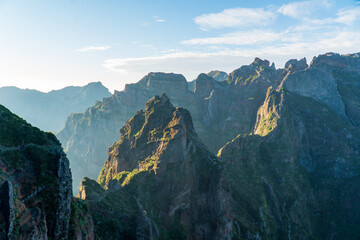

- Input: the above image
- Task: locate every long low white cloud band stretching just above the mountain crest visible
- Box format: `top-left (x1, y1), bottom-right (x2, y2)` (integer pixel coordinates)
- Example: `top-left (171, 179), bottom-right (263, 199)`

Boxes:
top-left (103, 28), bottom-right (360, 77)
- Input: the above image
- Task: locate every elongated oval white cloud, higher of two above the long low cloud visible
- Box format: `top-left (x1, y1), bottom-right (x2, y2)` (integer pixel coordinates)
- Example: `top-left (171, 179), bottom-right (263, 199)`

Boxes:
top-left (194, 8), bottom-right (276, 30)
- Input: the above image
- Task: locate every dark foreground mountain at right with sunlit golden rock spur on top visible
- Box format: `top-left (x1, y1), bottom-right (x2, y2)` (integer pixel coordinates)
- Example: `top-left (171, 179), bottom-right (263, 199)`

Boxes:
top-left (219, 88), bottom-right (360, 239)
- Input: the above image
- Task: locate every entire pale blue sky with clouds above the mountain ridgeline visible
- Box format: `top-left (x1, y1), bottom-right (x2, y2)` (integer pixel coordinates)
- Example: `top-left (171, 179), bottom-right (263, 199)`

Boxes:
top-left (0, 0), bottom-right (360, 91)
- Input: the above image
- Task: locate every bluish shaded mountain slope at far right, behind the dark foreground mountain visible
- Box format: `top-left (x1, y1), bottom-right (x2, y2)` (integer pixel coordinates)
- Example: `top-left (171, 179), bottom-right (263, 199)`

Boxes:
top-left (281, 53), bottom-right (360, 126)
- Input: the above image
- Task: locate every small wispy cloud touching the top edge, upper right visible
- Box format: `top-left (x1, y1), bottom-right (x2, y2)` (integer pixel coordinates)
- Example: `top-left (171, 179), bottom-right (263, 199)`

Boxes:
top-left (278, 0), bottom-right (333, 19)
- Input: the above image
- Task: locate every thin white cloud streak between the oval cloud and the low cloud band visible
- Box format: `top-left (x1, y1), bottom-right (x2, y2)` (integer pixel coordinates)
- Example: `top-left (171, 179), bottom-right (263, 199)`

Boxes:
top-left (181, 30), bottom-right (281, 45)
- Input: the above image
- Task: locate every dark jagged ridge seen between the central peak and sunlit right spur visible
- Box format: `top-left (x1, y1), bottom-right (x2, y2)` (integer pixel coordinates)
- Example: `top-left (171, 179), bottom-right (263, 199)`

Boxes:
top-left (201, 58), bottom-right (287, 152)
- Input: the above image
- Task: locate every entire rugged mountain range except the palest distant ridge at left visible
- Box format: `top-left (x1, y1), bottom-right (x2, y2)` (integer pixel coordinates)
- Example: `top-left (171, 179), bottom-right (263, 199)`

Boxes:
top-left (0, 53), bottom-right (360, 240)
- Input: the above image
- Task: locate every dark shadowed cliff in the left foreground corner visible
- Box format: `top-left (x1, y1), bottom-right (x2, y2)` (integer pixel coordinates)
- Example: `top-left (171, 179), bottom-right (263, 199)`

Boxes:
top-left (0, 105), bottom-right (72, 239)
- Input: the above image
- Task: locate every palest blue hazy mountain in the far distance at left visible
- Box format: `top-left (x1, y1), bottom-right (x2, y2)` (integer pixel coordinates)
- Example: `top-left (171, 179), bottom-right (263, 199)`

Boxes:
top-left (0, 82), bottom-right (111, 133)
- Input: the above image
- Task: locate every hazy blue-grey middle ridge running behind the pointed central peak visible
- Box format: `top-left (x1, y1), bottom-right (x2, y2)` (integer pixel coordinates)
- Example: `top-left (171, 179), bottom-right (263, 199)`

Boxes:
top-left (57, 58), bottom-right (286, 189)
